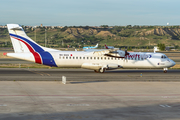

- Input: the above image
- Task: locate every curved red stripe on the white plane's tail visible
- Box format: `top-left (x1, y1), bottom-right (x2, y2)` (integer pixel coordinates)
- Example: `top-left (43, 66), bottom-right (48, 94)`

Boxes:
top-left (11, 36), bottom-right (42, 64)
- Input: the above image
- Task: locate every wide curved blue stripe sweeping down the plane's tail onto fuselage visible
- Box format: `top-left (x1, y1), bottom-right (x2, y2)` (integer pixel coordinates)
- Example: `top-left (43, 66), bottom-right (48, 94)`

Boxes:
top-left (10, 33), bottom-right (57, 67)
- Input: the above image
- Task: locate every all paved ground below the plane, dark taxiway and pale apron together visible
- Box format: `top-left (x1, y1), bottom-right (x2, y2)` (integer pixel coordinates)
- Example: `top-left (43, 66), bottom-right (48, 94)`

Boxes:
top-left (0, 68), bottom-right (180, 120)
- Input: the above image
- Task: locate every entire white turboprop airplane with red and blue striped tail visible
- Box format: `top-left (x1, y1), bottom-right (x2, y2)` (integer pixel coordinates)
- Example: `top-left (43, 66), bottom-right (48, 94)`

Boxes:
top-left (7, 24), bottom-right (175, 73)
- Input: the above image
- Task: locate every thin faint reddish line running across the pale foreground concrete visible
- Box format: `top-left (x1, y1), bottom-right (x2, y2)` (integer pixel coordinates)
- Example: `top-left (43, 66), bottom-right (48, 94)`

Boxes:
top-left (0, 94), bottom-right (180, 97)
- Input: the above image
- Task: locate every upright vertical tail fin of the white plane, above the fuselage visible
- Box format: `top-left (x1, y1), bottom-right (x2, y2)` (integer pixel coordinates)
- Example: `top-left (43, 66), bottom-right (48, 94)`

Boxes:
top-left (7, 24), bottom-right (44, 53)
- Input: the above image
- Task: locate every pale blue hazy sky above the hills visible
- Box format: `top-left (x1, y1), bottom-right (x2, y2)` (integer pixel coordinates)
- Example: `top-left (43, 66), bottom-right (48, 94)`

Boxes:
top-left (0, 0), bottom-right (180, 26)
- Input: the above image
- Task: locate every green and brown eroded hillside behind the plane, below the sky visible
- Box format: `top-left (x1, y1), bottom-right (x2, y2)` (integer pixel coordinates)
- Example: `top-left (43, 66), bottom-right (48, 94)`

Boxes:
top-left (0, 26), bottom-right (180, 47)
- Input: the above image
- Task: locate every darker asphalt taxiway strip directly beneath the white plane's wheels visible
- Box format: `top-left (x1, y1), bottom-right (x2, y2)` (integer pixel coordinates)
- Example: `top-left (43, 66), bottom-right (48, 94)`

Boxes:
top-left (0, 68), bottom-right (180, 82)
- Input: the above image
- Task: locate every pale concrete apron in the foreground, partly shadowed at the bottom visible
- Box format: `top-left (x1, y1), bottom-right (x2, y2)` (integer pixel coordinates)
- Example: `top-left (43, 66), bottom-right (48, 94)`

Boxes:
top-left (0, 81), bottom-right (180, 120)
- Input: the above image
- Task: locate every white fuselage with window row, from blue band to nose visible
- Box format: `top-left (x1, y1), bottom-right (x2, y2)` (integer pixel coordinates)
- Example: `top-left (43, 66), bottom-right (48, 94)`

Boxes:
top-left (50, 51), bottom-right (175, 68)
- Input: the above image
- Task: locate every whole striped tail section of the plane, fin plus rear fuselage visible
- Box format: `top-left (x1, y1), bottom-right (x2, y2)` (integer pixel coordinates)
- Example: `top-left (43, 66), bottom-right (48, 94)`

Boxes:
top-left (7, 24), bottom-right (59, 67)
